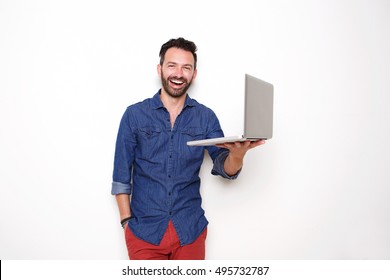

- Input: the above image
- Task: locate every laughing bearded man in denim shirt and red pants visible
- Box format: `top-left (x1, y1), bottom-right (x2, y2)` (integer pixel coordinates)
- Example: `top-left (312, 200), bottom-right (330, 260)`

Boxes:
top-left (112, 38), bottom-right (264, 259)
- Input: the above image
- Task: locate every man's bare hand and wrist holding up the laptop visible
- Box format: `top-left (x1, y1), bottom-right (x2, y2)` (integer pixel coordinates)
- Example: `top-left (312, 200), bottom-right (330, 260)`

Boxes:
top-left (216, 140), bottom-right (265, 176)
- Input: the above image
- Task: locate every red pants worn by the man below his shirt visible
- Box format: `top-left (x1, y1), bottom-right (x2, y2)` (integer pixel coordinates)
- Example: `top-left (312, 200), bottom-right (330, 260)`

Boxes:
top-left (125, 221), bottom-right (207, 260)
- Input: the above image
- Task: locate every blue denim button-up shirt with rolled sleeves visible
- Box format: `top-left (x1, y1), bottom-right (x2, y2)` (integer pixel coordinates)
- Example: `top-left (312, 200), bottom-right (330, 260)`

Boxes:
top-left (111, 91), bottom-right (238, 246)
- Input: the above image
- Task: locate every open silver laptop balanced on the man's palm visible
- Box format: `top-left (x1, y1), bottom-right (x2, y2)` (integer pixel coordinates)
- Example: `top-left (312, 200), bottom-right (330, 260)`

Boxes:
top-left (187, 74), bottom-right (274, 146)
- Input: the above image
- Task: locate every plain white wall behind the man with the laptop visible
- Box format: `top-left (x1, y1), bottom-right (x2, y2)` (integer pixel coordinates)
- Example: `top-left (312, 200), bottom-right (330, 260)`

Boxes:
top-left (0, 0), bottom-right (390, 259)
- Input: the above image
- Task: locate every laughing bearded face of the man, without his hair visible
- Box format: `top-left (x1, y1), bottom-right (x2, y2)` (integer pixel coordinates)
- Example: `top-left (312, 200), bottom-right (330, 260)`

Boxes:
top-left (158, 48), bottom-right (197, 98)
